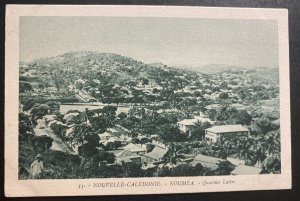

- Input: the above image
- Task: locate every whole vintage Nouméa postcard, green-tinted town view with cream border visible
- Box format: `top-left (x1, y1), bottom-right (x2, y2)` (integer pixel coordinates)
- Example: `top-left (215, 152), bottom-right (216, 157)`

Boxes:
top-left (5, 6), bottom-right (291, 195)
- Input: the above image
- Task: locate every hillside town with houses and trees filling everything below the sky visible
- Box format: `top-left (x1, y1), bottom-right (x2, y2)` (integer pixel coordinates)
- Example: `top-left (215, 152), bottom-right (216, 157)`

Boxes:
top-left (19, 52), bottom-right (281, 179)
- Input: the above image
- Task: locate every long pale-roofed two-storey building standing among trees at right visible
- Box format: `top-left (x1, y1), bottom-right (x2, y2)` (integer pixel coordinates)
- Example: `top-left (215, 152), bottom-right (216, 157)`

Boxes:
top-left (205, 124), bottom-right (250, 142)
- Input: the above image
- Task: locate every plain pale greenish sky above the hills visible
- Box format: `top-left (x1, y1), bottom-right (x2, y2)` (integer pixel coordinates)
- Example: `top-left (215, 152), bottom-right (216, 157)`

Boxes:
top-left (19, 16), bottom-right (278, 68)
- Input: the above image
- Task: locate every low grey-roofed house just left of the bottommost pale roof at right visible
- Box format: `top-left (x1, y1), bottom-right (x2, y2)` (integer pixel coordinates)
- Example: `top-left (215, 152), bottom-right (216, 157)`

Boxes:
top-left (191, 154), bottom-right (225, 170)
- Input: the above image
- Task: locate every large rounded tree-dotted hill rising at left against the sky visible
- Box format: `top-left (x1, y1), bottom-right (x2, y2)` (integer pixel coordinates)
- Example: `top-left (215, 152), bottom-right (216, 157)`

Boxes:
top-left (21, 51), bottom-right (192, 85)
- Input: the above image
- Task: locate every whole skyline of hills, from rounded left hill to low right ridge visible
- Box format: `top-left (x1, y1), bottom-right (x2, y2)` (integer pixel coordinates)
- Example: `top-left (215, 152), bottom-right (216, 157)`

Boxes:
top-left (22, 51), bottom-right (279, 83)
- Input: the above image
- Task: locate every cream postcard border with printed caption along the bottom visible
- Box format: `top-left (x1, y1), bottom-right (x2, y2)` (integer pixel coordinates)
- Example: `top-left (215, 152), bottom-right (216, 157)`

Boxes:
top-left (5, 5), bottom-right (291, 197)
